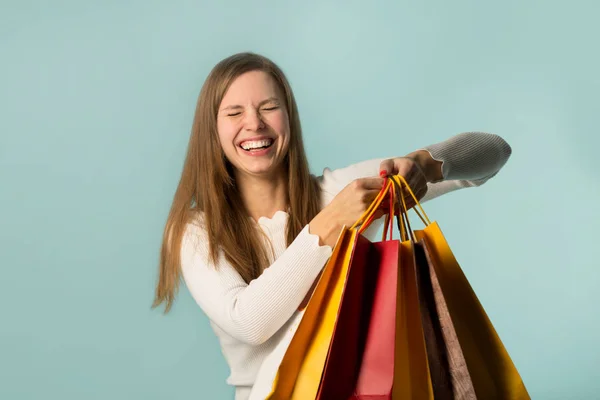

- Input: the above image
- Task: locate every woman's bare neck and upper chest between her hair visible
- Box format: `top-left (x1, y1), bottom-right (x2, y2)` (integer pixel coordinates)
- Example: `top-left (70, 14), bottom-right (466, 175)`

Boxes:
top-left (236, 173), bottom-right (288, 221)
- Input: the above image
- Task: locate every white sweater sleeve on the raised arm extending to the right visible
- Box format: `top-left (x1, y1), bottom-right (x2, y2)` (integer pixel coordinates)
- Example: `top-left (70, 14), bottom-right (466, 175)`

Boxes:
top-left (321, 132), bottom-right (512, 203)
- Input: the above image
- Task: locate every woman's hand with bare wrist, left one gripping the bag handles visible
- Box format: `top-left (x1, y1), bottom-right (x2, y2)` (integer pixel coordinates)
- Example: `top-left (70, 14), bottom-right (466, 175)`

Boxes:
top-left (309, 177), bottom-right (385, 247)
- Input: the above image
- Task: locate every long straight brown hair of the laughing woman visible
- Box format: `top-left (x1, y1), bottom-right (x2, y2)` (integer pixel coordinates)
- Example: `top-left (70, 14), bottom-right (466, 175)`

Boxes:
top-left (152, 53), bottom-right (320, 313)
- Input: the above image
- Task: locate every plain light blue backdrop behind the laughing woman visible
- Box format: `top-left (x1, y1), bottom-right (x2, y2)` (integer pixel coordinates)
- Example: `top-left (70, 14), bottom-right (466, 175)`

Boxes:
top-left (0, 0), bottom-right (600, 400)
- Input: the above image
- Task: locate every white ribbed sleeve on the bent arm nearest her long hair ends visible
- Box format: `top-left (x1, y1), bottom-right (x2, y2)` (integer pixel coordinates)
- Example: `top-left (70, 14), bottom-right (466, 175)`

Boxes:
top-left (181, 217), bottom-right (332, 345)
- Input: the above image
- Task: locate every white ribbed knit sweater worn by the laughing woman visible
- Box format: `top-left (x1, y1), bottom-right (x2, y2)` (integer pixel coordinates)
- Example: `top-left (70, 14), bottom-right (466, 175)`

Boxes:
top-left (181, 132), bottom-right (511, 400)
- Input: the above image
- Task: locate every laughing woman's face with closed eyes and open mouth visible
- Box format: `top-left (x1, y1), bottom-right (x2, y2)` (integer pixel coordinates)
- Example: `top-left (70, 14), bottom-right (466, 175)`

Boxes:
top-left (217, 71), bottom-right (290, 177)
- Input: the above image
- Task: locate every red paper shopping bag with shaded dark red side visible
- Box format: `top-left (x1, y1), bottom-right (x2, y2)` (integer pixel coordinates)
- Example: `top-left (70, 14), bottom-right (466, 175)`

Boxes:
top-left (317, 182), bottom-right (398, 400)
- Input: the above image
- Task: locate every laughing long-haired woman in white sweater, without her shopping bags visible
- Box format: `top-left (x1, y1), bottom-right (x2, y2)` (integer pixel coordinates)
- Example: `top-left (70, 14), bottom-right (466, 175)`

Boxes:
top-left (154, 53), bottom-right (511, 399)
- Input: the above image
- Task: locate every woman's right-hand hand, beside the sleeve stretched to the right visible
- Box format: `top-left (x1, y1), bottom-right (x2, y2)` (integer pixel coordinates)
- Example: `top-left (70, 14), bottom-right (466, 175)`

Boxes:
top-left (379, 151), bottom-right (441, 209)
